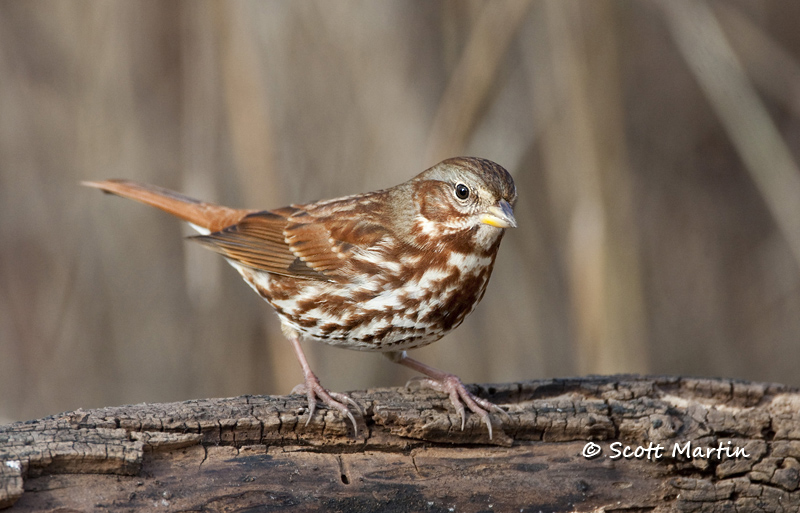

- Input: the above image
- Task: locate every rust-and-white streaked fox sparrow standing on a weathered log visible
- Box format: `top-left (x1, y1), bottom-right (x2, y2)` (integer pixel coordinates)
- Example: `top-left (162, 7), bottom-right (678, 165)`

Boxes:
top-left (84, 157), bottom-right (517, 438)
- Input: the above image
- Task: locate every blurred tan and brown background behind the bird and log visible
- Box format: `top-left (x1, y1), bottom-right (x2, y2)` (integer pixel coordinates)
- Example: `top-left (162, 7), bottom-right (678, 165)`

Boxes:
top-left (0, 0), bottom-right (800, 421)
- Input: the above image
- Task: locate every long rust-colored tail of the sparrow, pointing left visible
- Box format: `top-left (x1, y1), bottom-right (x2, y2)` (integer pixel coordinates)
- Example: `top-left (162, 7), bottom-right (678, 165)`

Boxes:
top-left (81, 180), bottom-right (255, 232)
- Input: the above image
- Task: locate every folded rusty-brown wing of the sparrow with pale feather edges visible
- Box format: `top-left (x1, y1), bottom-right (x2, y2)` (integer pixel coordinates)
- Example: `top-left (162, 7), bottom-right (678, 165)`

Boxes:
top-left (192, 194), bottom-right (388, 281)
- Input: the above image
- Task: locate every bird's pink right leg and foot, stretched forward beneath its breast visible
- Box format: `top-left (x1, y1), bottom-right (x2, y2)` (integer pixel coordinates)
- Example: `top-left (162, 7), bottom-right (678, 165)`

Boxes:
top-left (386, 351), bottom-right (508, 440)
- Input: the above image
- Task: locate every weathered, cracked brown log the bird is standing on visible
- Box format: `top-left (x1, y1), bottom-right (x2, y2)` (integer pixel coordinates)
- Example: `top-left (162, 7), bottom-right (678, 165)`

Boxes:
top-left (0, 376), bottom-right (800, 512)
